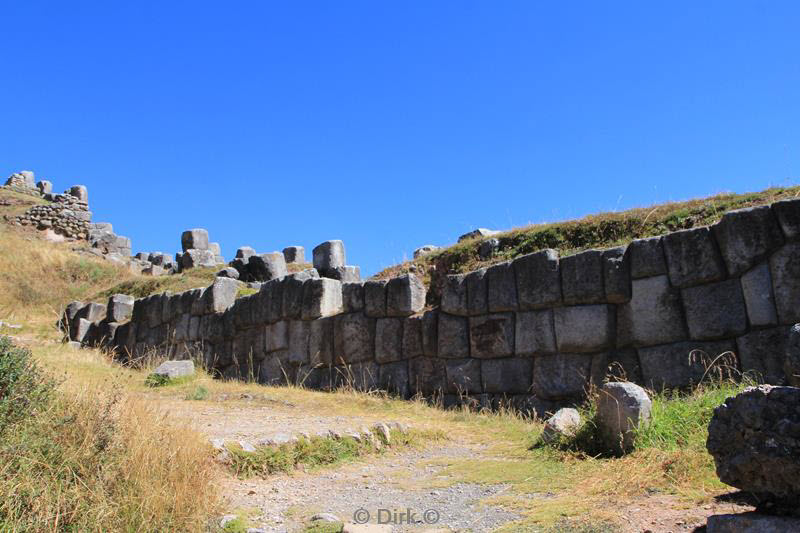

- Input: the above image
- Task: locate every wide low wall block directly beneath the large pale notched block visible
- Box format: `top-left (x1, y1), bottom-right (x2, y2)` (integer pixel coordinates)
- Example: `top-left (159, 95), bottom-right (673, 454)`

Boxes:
top-left (639, 341), bottom-right (736, 390)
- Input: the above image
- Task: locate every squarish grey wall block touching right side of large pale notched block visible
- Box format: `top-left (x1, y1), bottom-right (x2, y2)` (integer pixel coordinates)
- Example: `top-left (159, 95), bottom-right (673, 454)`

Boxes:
top-left (681, 279), bottom-right (747, 340)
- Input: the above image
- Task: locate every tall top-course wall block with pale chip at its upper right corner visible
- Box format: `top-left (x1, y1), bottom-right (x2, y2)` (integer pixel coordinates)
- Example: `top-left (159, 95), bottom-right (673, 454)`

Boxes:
top-left (511, 249), bottom-right (561, 310)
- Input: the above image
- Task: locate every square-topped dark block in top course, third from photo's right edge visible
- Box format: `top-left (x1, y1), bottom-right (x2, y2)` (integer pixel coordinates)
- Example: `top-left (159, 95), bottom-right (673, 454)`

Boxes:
top-left (663, 227), bottom-right (725, 288)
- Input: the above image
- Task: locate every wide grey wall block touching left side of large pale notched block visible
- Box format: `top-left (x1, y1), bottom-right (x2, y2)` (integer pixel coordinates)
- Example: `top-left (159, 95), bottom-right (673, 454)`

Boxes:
top-left (553, 304), bottom-right (616, 353)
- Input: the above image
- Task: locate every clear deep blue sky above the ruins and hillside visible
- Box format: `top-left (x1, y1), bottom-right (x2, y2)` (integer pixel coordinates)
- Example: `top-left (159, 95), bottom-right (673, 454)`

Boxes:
top-left (0, 0), bottom-right (800, 274)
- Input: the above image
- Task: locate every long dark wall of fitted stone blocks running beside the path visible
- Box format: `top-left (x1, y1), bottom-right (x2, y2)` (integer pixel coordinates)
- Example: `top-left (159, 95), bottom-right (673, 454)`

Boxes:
top-left (65, 200), bottom-right (800, 412)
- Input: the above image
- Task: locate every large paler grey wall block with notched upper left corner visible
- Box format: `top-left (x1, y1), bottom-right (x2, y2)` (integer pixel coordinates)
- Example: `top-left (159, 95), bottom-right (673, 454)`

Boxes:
top-left (617, 276), bottom-right (687, 346)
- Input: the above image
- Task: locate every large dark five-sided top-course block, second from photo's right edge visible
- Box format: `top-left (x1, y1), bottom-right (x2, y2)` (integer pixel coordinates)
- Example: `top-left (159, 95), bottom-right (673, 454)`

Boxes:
top-left (712, 205), bottom-right (783, 276)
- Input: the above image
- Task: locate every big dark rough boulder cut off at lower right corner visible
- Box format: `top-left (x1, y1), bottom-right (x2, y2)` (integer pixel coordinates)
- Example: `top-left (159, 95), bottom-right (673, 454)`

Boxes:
top-left (707, 385), bottom-right (800, 513)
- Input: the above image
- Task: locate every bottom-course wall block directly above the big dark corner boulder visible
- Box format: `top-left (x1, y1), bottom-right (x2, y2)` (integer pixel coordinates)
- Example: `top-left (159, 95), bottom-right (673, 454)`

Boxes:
top-left (736, 326), bottom-right (791, 385)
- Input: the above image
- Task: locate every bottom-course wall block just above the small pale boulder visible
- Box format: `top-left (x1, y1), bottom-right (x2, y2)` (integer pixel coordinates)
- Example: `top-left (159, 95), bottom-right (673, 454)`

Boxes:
top-left (532, 354), bottom-right (592, 400)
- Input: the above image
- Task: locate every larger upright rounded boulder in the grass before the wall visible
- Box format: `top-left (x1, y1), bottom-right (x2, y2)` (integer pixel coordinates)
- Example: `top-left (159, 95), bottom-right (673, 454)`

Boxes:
top-left (595, 382), bottom-right (653, 454)
